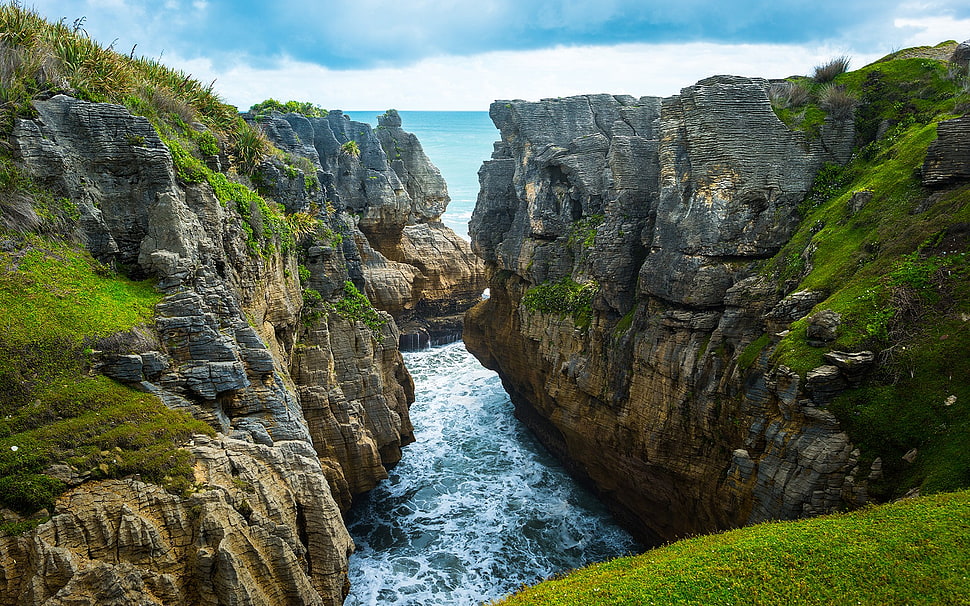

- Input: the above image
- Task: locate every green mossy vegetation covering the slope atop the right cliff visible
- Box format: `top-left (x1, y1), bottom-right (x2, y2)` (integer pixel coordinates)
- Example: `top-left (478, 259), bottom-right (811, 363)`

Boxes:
top-left (766, 55), bottom-right (970, 498)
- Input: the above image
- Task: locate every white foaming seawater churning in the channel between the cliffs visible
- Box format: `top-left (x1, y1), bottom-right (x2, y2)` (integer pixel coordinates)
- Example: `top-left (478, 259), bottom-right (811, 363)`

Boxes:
top-left (345, 343), bottom-right (636, 606)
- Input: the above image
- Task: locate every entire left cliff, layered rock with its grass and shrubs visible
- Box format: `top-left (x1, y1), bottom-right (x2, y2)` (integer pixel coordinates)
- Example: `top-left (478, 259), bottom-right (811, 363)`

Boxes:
top-left (0, 6), bottom-right (481, 605)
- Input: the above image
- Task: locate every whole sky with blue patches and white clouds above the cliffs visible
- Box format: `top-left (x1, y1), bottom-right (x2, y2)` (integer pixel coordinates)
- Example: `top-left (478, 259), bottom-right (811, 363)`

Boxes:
top-left (24, 0), bottom-right (970, 110)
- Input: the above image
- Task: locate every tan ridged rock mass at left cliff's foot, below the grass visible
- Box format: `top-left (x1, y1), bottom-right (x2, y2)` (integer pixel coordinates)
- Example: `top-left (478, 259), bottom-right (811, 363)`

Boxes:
top-left (0, 437), bottom-right (353, 606)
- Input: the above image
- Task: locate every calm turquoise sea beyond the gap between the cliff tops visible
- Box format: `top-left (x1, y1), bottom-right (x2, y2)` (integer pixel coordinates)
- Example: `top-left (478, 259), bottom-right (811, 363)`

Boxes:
top-left (345, 110), bottom-right (499, 240)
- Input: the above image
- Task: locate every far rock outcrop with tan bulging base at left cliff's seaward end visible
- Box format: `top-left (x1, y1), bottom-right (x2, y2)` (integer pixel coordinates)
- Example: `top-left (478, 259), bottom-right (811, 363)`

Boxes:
top-left (251, 110), bottom-right (485, 342)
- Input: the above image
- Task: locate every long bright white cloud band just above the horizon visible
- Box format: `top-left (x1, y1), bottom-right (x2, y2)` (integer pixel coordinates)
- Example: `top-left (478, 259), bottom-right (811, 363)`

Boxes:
top-left (166, 43), bottom-right (888, 110)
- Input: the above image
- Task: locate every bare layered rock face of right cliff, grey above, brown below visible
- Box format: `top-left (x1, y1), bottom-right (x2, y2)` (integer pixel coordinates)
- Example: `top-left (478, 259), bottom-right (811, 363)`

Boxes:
top-left (465, 82), bottom-right (868, 542)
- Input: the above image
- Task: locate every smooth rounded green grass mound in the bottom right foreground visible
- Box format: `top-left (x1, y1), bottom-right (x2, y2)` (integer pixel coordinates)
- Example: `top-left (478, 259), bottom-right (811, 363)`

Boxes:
top-left (497, 492), bottom-right (970, 606)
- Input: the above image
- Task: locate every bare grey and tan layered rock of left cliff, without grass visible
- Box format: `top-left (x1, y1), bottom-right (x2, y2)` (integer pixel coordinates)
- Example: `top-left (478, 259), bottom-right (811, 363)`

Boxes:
top-left (0, 96), bottom-right (460, 605)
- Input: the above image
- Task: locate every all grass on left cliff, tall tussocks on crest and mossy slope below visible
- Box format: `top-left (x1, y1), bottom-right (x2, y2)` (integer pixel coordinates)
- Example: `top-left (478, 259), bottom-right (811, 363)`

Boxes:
top-left (0, 4), bottom-right (242, 532)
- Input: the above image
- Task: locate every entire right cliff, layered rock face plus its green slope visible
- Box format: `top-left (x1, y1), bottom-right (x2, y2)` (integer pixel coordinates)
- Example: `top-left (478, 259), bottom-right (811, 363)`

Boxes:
top-left (465, 47), bottom-right (970, 543)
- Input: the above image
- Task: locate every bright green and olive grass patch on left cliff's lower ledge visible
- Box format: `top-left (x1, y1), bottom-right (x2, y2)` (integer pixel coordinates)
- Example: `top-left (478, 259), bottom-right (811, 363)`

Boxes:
top-left (0, 236), bottom-right (212, 516)
